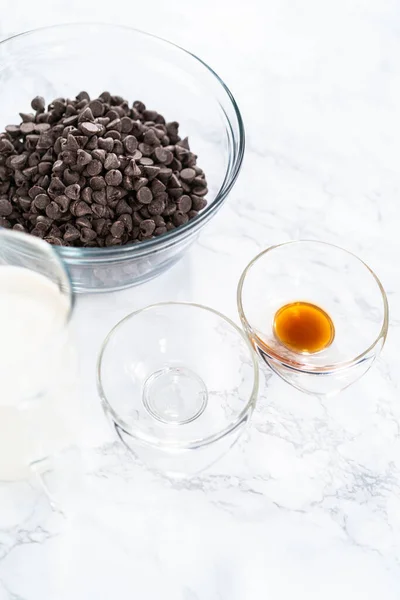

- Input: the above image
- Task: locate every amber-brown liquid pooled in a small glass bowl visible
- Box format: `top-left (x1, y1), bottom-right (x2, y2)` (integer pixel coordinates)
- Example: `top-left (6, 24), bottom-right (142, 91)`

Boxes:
top-left (274, 302), bottom-right (335, 354)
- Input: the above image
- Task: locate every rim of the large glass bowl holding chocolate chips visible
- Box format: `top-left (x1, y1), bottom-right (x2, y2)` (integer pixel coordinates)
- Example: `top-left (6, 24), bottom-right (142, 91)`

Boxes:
top-left (0, 21), bottom-right (245, 260)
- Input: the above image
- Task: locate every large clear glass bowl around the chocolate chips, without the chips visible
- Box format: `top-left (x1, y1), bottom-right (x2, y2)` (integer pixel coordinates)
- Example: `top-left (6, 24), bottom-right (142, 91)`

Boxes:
top-left (0, 24), bottom-right (244, 292)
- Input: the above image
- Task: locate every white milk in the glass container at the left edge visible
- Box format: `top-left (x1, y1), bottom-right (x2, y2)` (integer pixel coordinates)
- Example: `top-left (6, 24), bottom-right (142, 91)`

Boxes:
top-left (0, 265), bottom-right (79, 480)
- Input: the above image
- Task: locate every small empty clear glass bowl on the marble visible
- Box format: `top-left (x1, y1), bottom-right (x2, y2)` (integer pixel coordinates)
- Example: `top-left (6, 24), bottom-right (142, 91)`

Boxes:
top-left (97, 303), bottom-right (258, 477)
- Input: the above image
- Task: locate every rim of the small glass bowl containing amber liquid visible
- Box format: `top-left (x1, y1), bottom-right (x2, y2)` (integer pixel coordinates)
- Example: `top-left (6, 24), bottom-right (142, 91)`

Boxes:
top-left (236, 240), bottom-right (389, 375)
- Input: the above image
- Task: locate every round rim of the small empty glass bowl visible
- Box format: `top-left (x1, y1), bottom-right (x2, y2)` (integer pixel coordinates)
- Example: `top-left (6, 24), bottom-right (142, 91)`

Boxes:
top-left (96, 301), bottom-right (259, 451)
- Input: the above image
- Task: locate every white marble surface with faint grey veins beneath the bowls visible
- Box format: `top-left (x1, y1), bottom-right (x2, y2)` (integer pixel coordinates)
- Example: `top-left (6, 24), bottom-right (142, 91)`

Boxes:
top-left (0, 0), bottom-right (400, 600)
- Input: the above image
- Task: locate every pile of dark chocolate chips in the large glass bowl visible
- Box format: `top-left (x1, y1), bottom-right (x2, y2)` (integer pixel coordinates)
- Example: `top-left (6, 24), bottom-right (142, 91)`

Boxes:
top-left (0, 92), bottom-right (208, 247)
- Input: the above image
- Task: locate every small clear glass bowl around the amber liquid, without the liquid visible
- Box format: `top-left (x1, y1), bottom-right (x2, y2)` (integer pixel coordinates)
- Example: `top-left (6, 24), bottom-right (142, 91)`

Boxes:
top-left (237, 241), bottom-right (388, 395)
